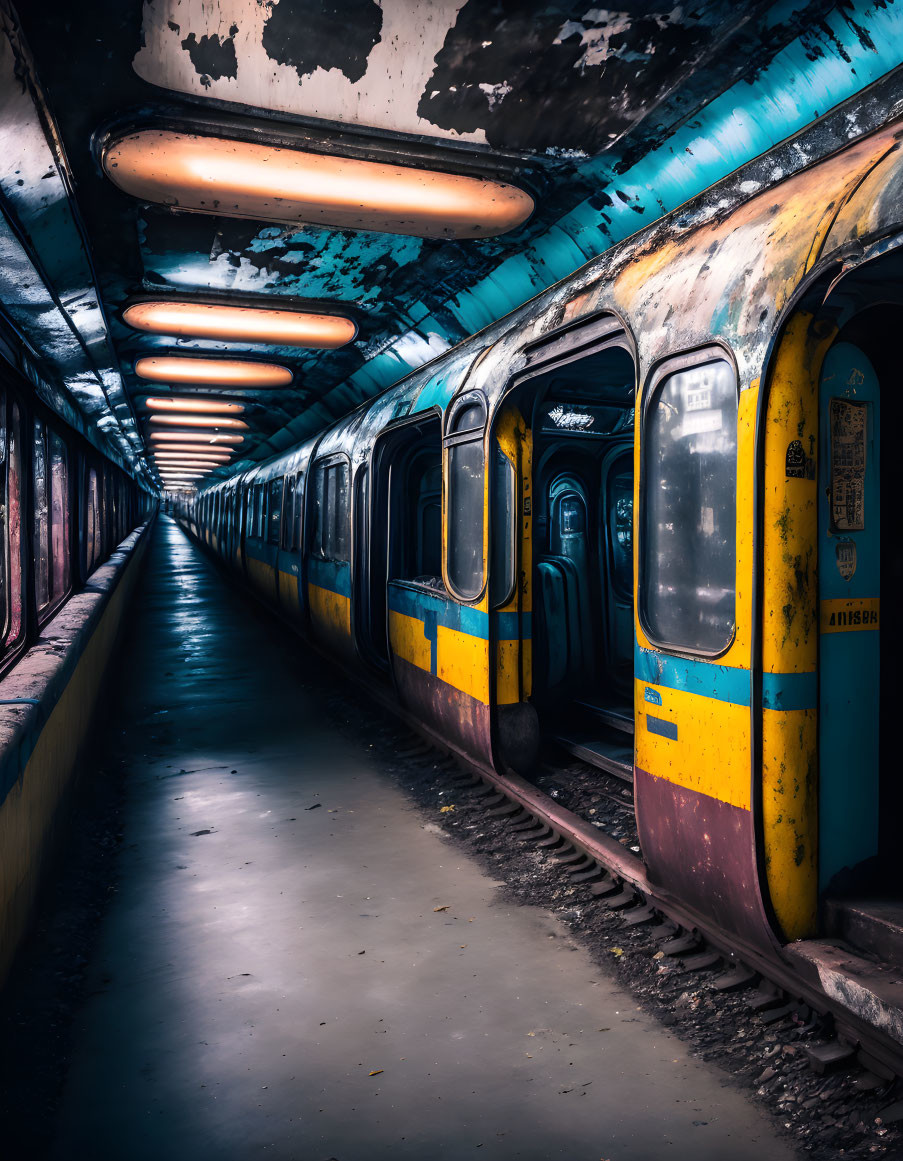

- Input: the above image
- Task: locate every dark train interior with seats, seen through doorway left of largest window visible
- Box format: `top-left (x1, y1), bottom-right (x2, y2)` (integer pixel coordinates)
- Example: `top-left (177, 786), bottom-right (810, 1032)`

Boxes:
top-left (526, 345), bottom-right (636, 780)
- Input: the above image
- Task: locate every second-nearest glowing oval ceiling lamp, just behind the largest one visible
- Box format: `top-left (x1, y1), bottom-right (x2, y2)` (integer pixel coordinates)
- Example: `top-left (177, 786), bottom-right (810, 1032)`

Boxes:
top-left (122, 302), bottom-right (357, 349)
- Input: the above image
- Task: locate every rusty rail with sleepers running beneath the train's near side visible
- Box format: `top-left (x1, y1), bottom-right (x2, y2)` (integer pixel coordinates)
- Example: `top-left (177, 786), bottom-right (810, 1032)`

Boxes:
top-left (387, 727), bottom-right (903, 1084)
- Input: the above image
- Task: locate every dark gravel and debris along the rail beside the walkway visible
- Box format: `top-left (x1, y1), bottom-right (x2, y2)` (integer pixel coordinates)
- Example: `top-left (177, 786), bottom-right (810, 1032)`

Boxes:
top-left (318, 678), bottom-right (903, 1161)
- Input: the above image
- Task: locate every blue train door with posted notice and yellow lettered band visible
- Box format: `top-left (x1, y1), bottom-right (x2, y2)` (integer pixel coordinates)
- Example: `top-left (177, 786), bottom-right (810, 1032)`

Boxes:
top-left (818, 341), bottom-right (881, 890)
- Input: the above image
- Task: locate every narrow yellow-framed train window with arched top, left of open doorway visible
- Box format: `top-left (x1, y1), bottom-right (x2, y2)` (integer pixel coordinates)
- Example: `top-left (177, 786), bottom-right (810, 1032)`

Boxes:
top-left (446, 395), bottom-right (486, 600)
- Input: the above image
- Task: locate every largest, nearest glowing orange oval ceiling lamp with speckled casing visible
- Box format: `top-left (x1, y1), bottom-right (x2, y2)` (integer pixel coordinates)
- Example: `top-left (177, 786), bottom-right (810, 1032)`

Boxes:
top-left (103, 129), bottom-right (533, 238)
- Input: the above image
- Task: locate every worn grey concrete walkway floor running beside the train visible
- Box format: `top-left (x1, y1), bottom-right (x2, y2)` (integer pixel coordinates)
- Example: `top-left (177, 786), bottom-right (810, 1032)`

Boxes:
top-left (53, 518), bottom-right (795, 1161)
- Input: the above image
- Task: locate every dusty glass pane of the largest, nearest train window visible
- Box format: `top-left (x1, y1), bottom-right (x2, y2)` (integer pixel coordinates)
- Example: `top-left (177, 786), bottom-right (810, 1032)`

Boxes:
top-left (642, 359), bottom-right (738, 654)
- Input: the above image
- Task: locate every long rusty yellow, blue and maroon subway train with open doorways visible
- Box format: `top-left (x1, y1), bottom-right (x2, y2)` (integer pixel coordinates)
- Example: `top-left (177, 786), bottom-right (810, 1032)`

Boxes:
top-left (178, 110), bottom-right (903, 998)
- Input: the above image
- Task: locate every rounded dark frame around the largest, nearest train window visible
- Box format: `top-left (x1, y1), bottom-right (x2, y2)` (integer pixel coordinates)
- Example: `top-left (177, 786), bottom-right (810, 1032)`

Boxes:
top-left (634, 339), bottom-right (743, 661)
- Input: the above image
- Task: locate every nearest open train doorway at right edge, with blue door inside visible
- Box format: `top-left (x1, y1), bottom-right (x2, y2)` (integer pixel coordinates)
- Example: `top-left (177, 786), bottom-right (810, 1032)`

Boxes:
top-left (818, 280), bottom-right (903, 962)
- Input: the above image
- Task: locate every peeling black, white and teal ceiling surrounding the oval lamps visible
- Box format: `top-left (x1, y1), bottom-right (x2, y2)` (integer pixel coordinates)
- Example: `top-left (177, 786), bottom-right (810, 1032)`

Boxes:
top-left (2, 0), bottom-right (898, 485)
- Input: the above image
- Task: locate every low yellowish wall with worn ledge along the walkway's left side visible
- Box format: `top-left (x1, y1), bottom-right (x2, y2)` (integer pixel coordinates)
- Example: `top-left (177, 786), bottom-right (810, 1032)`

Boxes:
top-left (0, 524), bottom-right (150, 985)
